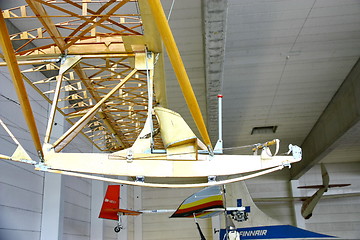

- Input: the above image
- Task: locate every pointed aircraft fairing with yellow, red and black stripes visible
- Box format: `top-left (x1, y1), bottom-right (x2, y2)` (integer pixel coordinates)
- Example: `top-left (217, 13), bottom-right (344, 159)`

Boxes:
top-left (171, 186), bottom-right (225, 218)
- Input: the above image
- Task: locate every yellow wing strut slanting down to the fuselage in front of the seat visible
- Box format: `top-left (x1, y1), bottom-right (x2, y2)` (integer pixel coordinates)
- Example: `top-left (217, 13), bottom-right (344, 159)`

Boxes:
top-left (148, 0), bottom-right (213, 153)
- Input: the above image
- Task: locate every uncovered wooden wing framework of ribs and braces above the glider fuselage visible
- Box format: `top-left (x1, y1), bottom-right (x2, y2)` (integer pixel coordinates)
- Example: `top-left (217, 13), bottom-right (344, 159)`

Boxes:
top-left (2, 0), bottom-right (164, 152)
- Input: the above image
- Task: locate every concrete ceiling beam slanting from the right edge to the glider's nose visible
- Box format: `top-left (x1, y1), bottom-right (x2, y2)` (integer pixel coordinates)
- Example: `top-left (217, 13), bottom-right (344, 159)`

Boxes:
top-left (291, 59), bottom-right (360, 179)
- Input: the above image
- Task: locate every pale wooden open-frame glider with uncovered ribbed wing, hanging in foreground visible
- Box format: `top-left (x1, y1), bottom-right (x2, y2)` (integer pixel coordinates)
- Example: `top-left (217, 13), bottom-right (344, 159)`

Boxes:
top-left (0, 0), bottom-right (301, 187)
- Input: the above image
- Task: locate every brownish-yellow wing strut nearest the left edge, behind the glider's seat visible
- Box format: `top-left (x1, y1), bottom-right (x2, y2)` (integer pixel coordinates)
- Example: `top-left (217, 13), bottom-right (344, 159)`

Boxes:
top-left (0, 9), bottom-right (44, 161)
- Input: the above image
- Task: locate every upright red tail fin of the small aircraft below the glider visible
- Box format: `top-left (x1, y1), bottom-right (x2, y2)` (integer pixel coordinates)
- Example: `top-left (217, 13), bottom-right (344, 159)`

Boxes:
top-left (99, 185), bottom-right (120, 220)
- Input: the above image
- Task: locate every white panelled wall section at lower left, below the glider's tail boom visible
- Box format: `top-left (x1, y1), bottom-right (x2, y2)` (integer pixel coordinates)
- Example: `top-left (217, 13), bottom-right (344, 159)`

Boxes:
top-left (0, 161), bottom-right (43, 240)
